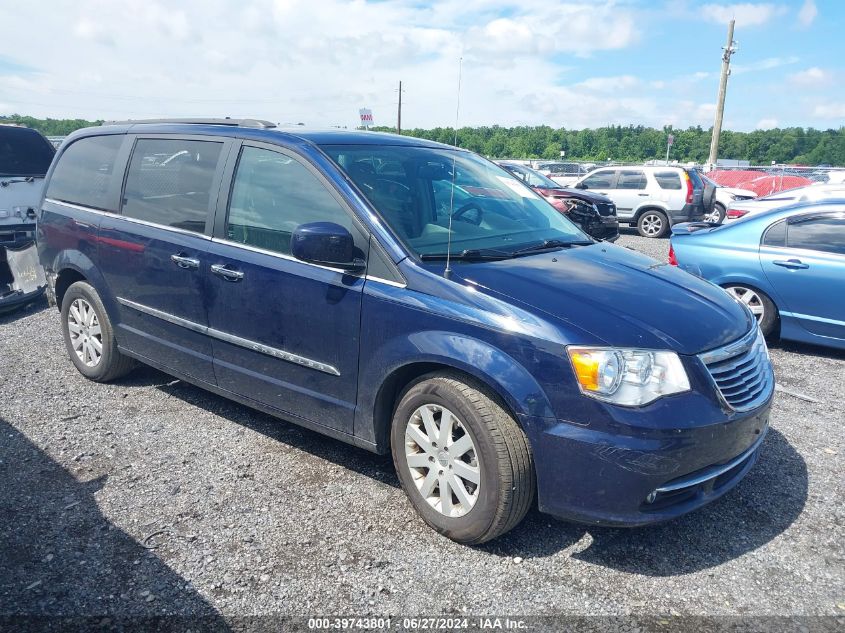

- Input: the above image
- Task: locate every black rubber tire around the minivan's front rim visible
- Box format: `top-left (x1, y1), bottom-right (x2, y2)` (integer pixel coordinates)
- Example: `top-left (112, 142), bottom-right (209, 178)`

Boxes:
top-left (390, 373), bottom-right (535, 545)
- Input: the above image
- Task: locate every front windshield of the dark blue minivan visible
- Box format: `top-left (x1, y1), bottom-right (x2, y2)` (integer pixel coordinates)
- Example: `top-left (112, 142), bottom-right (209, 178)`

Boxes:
top-left (321, 145), bottom-right (592, 259)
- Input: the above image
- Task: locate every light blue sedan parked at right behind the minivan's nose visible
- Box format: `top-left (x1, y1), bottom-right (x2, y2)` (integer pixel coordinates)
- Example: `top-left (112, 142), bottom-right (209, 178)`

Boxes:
top-left (669, 200), bottom-right (845, 349)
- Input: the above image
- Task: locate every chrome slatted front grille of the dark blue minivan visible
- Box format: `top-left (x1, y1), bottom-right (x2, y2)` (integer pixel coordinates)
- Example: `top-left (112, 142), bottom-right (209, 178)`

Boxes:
top-left (699, 325), bottom-right (775, 411)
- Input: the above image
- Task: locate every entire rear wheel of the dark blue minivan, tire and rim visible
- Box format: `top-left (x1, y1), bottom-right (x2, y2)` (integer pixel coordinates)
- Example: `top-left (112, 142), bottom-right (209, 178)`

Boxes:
top-left (61, 281), bottom-right (136, 382)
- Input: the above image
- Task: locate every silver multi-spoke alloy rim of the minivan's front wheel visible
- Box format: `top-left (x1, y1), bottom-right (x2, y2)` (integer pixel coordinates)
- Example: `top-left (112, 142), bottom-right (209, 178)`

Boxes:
top-left (405, 404), bottom-right (481, 517)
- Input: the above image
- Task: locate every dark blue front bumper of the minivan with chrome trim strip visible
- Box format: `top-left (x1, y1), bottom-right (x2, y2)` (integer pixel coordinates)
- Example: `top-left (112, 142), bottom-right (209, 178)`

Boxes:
top-left (521, 398), bottom-right (771, 527)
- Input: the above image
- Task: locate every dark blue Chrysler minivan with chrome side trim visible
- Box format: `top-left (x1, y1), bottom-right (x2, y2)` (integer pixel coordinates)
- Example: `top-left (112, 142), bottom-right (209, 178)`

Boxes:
top-left (38, 119), bottom-right (774, 543)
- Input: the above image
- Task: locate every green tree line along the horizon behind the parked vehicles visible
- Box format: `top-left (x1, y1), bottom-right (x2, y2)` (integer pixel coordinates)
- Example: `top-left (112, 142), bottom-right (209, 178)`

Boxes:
top-left (0, 114), bottom-right (845, 166)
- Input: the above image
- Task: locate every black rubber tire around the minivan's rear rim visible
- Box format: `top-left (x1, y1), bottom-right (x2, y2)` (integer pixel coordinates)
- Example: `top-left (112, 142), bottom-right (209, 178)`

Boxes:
top-left (61, 281), bottom-right (137, 382)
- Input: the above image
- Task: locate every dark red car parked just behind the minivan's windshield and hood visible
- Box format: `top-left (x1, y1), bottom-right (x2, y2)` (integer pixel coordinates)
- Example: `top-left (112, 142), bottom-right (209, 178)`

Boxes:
top-left (499, 162), bottom-right (619, 242)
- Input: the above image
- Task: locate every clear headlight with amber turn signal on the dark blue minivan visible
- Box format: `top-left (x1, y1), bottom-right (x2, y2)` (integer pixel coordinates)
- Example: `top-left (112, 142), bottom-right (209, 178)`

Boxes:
top-left (567, 347), bottom-right (689, 407)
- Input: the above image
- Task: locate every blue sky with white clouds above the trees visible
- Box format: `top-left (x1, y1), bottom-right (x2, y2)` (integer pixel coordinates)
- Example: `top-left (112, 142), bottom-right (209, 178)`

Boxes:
top-left (0, 0), bottom-right (845, 131)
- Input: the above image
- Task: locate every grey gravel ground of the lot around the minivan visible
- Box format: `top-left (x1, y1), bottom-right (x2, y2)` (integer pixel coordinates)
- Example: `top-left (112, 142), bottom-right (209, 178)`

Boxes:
top-left (0, 232), bottom-right (845, 622)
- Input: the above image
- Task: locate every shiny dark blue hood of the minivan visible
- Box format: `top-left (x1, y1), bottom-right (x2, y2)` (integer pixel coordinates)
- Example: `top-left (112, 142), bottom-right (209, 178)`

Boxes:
top-left (436, 243), bottom-right (753, 354)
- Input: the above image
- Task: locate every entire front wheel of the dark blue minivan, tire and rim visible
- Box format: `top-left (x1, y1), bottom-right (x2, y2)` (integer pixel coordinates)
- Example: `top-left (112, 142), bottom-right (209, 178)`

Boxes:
top-left (390, 373), bottom-right (535, 544)
